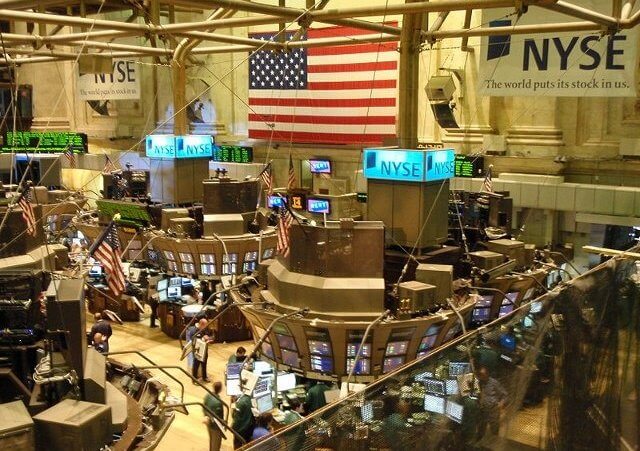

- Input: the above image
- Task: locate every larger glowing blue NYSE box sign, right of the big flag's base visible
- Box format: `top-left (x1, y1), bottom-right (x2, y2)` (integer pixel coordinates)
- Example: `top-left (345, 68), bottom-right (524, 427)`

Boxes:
top-left (364, 149), bottom-right (455, 182)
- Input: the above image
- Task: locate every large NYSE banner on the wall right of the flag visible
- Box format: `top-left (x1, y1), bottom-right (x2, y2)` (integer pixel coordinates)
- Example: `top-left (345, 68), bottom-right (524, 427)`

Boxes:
top-left (478, 0), bottom-right (639, 97)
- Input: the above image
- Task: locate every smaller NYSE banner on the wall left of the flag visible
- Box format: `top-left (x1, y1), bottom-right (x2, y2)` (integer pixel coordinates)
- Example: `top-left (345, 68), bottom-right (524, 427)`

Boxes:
top-left (78, 59), bottom-right (140, 100)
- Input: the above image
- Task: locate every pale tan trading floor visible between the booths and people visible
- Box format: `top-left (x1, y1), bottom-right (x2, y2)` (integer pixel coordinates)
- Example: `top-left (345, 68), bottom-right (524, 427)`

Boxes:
top-left (109, 319), bottom-right (252, 451)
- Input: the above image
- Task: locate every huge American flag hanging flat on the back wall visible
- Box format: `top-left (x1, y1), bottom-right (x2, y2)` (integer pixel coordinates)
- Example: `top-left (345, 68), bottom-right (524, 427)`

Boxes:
top-left (249, 27), bottom-right (398, 144)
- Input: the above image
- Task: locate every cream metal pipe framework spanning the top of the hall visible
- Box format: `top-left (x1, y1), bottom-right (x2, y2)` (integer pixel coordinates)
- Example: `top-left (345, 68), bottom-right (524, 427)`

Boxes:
top-left (0, 0), bottom-right (640, 65)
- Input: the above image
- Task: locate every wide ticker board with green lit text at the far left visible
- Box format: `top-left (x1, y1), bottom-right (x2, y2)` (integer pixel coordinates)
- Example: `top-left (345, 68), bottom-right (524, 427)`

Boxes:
top-left (2, 132), bottom-right (88, 153)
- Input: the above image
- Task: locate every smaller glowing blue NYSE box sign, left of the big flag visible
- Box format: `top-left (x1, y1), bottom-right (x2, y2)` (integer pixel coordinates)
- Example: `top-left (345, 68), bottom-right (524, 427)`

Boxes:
top-left (145, 135), bottom-right (213, 159)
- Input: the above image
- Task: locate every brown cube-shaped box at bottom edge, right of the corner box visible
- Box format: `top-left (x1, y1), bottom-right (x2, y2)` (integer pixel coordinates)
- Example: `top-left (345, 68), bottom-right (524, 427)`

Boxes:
top-left (33, 399), bottom-right (112, 451)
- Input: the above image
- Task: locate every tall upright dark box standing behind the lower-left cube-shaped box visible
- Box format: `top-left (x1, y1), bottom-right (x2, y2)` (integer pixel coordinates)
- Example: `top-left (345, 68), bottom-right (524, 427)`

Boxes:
top-left (47, 279), bottom-right (87, 379)
